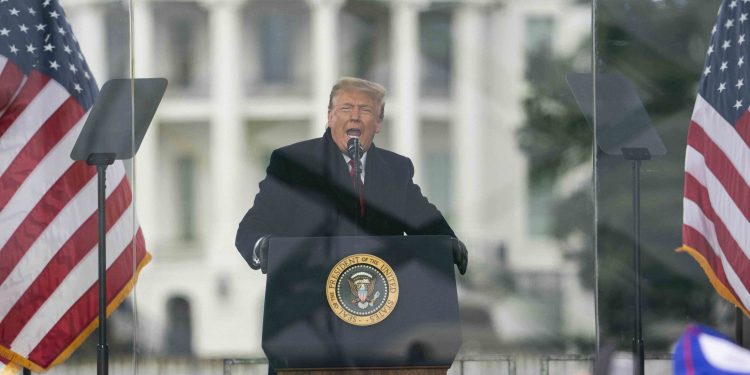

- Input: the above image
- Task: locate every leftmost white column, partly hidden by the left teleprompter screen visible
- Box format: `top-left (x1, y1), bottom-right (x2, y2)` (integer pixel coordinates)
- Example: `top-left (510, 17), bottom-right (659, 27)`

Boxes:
top-left (133, 0), bottom-right (162, 252)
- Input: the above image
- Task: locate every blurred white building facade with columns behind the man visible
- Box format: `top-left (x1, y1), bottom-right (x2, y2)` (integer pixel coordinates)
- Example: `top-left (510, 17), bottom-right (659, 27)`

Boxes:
top-left (64, 0), bottom-right (594, 357)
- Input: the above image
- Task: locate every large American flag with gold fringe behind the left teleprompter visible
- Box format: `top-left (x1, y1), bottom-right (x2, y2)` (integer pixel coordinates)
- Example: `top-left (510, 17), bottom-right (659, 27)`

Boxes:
top-left (0, 0), bottom-right (150, 371)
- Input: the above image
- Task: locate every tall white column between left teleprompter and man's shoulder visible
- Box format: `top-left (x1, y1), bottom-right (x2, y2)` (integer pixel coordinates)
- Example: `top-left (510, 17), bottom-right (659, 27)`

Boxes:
top-left (205, 0), bottom-right (246, 265)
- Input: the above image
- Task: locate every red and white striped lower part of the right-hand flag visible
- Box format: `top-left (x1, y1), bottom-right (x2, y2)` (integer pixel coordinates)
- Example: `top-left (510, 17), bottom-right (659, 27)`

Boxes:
top-left (681, 95), bottom-right (750, 314)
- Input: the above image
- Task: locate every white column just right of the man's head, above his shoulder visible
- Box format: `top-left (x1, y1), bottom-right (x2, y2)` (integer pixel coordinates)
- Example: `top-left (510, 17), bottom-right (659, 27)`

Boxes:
top-left (386, 0), bottom-right (427, 182)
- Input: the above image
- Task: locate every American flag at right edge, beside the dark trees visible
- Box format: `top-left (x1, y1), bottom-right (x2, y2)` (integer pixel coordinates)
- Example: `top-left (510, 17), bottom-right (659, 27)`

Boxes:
top-left (682, 0), bottom-right (750, 314)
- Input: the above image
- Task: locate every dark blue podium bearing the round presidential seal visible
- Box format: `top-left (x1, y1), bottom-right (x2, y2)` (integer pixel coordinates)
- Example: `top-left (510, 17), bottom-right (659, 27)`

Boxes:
top-left (262, 236), bottom-right (461, 375)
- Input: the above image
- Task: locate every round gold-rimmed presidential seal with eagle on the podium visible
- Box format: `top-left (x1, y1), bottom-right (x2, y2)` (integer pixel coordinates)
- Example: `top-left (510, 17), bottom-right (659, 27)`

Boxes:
top-left (326, 254), bottom-right (398, 326)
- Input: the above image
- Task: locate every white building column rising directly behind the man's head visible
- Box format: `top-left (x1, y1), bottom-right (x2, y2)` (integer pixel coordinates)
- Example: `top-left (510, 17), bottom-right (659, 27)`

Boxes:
top-left (307, 0), bottom-right (344, 137)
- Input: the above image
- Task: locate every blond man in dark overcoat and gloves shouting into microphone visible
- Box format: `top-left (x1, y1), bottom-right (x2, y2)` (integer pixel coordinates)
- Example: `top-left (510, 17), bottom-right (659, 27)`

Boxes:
top-left (235, 77), bottom-right (468, 274)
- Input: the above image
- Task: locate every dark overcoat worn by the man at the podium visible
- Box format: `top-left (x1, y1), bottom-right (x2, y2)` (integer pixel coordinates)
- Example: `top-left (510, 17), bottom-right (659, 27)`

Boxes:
top-left (235, 129), bottom-right (455, 263)
